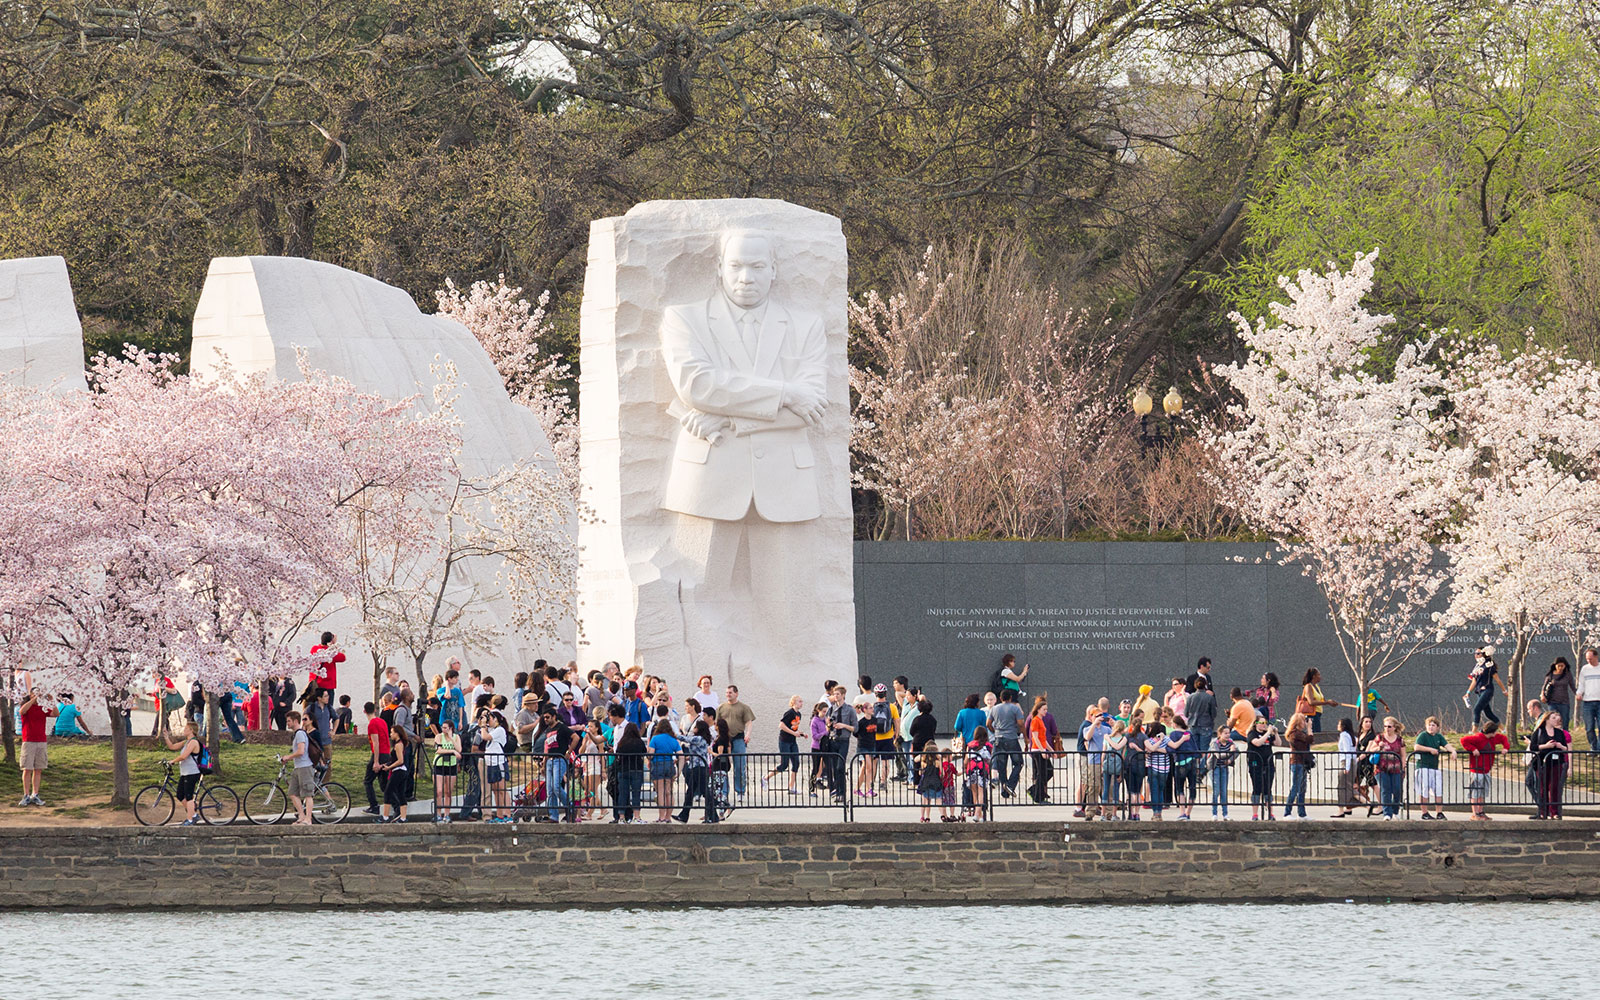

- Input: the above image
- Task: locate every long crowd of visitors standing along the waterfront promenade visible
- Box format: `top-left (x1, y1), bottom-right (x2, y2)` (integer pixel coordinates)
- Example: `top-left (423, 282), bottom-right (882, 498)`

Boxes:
top-left (6, 632), bottom-right (1600, 822)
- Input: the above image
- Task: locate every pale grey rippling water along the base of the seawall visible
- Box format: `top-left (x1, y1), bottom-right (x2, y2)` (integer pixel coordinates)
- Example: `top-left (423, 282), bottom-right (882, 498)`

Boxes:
top-left (0, 902), bottom-right (1600, 1000)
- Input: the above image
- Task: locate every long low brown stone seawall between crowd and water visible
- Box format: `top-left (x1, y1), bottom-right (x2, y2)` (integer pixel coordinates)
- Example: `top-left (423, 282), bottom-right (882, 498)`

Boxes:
top-left (0, 821), bottom-right (1600, 909)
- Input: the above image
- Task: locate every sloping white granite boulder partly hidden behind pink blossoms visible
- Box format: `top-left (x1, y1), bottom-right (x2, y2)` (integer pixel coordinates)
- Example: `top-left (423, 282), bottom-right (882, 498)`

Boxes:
top-left (190, 258), bottom-right (574, 672)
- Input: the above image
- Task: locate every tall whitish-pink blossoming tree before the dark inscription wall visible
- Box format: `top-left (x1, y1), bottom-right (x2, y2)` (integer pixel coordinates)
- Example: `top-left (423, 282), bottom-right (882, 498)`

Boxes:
top-left (1208, 251), bottom-right (1467, 704)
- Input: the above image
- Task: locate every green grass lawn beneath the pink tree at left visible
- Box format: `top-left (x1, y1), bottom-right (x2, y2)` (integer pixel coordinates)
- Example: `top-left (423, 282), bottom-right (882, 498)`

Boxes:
top-left (0, 738), bottom-right (368, 822)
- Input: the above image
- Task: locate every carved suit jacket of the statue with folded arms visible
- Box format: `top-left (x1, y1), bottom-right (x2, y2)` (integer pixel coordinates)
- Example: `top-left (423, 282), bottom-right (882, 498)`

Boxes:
top-left (661, 291), bottom-right (827, 522)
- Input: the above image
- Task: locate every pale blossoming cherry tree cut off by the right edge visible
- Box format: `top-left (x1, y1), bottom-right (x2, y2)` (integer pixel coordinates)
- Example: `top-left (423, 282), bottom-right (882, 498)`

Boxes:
top-left (1440, 338), bottom-right (1600, 736)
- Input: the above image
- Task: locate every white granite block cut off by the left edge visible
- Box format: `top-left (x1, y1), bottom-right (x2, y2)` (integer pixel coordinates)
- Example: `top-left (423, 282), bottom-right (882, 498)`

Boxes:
top-left (0, 258), bottom-right (88, 392)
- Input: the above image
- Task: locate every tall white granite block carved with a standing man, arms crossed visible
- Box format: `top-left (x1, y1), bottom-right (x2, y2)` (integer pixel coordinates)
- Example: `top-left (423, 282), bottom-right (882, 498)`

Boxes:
top-left (578, 200), bottom-right (856, 720)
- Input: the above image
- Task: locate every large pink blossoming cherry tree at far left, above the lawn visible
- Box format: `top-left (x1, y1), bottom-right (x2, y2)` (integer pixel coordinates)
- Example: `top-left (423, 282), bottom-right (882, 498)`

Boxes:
top-left (0, 354), bottom-right (450, 805)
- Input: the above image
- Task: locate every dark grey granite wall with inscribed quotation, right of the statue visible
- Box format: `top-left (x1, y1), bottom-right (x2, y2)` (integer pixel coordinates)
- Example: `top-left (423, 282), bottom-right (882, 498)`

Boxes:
top-left (856, 542), bottom-right (1571, 730)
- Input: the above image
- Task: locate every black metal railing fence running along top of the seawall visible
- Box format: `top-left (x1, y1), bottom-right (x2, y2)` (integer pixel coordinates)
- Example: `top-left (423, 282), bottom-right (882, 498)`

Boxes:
top-left (416, 744), bottom-right (1600, 822)
